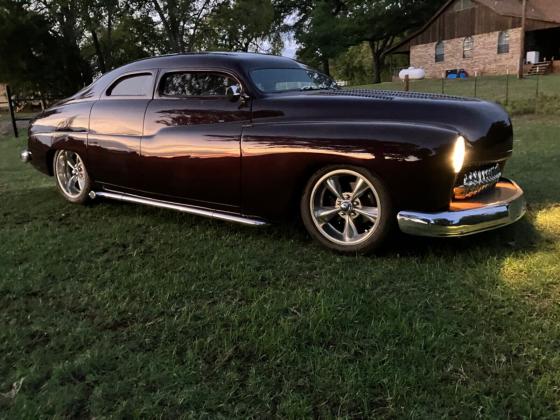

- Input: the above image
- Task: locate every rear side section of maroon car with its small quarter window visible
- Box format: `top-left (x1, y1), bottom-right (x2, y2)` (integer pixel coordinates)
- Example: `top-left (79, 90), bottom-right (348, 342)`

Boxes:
top-left (87, 71), bottom-right (156, 189)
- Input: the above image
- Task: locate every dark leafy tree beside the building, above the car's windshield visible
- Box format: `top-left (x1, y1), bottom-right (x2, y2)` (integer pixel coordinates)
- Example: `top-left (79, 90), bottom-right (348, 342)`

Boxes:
top-left (293, 0), bottom-right (445, 83)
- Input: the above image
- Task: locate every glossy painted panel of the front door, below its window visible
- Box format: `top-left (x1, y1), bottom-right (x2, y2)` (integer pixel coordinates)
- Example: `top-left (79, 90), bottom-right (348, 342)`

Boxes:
top-left (141, 97), bottom-right (251, 208)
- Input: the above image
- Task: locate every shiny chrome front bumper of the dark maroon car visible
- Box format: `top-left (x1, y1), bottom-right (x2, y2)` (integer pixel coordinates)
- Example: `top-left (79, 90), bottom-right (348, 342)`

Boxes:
top-left (397, 178), bottom-right (527, 237)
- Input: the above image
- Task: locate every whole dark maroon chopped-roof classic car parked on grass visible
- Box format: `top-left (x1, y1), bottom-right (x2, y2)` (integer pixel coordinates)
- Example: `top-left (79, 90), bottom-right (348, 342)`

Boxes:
top-left (22, 53), bottom-right (525, 252)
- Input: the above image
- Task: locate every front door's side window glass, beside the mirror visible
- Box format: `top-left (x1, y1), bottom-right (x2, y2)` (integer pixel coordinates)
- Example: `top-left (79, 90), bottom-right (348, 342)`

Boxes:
top-left (159, 72), bottom-right (241, 98)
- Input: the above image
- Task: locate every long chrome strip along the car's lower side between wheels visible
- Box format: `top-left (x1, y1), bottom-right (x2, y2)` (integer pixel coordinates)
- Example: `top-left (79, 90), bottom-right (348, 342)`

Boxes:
top-left (89, 191), bottom-right (268, 226)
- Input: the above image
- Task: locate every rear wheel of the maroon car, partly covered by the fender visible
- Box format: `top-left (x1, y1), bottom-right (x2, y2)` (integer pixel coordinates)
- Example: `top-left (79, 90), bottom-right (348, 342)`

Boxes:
top-left (53, 150), bottom-right (91, 204)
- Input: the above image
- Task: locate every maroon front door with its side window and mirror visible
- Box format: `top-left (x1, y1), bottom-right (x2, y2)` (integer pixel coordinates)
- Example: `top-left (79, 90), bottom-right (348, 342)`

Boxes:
top-left (141, 70), bottom-right (251, 210)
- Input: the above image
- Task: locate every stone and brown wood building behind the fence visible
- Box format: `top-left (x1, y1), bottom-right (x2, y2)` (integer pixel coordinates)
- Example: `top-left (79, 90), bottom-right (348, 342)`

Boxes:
top-left (390, 0), bottom-right (560, 78)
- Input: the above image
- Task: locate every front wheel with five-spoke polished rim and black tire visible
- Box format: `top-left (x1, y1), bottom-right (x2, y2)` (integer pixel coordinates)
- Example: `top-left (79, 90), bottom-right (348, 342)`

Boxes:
top-left (301, 166), bottom-right (394, 253)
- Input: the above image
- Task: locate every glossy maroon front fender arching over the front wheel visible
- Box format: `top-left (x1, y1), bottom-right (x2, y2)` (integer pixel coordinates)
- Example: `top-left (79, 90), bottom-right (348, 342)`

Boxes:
top-left (241, 121), bottom-right (460, 218)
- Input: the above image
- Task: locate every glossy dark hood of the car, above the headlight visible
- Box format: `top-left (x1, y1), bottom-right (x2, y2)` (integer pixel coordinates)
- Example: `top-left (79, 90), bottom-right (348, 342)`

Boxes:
top-left (254, 89), bottom-right (513, 163)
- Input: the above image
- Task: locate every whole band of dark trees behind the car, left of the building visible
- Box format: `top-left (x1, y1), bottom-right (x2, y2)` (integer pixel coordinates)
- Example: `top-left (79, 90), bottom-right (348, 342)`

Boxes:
top-left (0, 0), bottom-right (456, 94)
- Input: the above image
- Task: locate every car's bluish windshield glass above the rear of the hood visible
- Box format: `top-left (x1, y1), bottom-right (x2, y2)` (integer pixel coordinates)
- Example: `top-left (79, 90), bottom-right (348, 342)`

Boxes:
top-left (251, 68), bottom-right (338, 93)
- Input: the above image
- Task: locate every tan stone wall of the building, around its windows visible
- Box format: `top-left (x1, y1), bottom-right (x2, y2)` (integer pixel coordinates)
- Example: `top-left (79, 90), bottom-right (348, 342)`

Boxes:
top-left (410, 28), bottom-right (521, 78)
